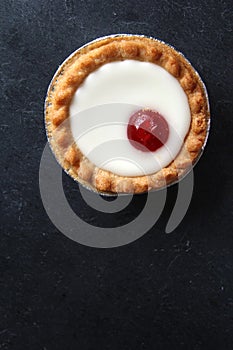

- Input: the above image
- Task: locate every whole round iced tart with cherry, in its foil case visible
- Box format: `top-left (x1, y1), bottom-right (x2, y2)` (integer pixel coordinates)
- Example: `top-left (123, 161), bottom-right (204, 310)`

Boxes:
top-left (45, 34), bottom-right (210, 194)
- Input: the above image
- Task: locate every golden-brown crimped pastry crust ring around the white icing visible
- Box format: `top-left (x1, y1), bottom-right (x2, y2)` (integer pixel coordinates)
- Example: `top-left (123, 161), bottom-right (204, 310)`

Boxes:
top-left (45, 35), bottom-right (210, 193)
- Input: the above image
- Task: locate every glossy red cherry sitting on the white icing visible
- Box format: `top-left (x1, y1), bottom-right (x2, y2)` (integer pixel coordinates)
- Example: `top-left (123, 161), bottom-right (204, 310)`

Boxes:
top-left (127, 109), bottom-right (169, 152)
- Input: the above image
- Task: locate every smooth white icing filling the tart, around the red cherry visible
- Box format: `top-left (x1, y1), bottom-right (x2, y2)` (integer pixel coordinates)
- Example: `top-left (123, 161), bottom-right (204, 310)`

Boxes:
top-left (70, 60), bottom-right (191, 176)
